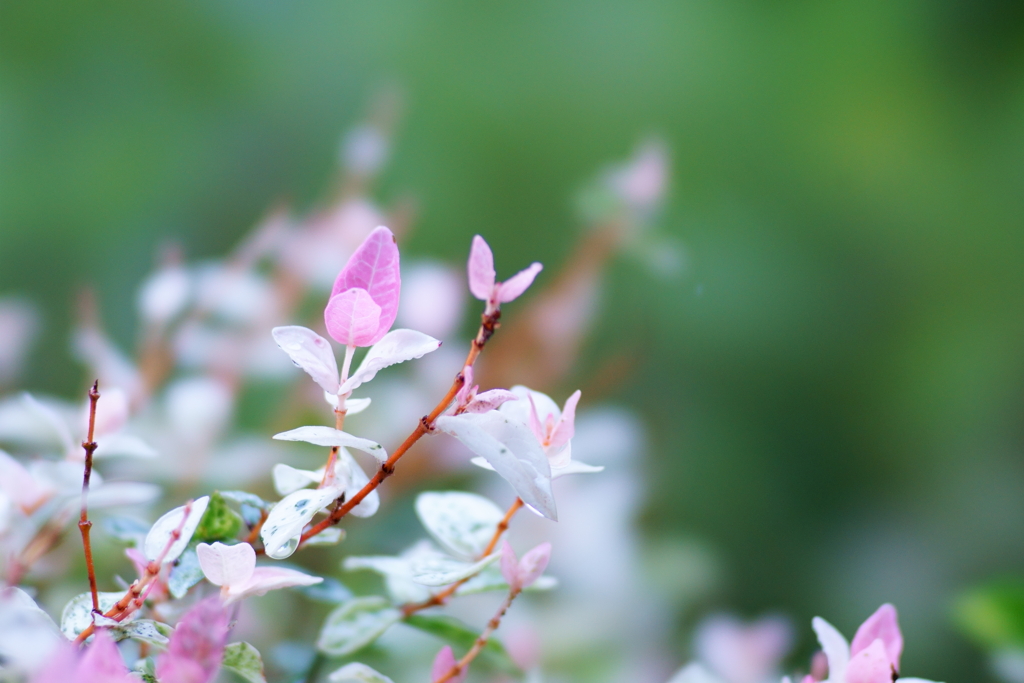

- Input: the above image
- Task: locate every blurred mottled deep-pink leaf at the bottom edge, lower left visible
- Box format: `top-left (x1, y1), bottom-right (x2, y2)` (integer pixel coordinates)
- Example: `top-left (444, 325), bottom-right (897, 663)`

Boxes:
top-left (157, 597), bottom-right (227, 683)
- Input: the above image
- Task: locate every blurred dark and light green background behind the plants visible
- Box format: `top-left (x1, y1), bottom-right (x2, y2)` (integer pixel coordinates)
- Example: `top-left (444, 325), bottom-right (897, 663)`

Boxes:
top-left (0, 0), bottom-right (1024, 681)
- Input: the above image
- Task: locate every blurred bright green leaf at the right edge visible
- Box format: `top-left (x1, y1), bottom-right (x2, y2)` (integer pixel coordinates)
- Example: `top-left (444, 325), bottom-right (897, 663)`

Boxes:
top-left (953, 580), bottom-right (1024, 648)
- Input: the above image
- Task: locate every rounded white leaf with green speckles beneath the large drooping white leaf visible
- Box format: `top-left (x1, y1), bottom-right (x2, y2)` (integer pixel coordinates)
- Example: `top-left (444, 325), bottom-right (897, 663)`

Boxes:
top-left (416, 492), bottom-right (505, 560)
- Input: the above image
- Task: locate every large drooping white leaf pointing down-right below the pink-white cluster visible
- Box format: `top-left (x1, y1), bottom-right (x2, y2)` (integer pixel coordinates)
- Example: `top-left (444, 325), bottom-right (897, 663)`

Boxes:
top-left (436, 413), bottom-right (558, 520)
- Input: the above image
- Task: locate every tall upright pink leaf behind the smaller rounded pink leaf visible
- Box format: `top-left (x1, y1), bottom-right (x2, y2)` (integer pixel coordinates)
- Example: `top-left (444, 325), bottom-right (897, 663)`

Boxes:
top-left (331, 225), bottom-right (401, 346)
